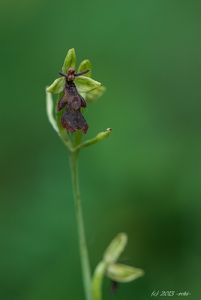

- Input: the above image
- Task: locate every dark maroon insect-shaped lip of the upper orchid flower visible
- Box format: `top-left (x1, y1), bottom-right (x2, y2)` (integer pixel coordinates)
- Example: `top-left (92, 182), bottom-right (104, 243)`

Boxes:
top-left (57, 68), bottom-right (88, 133)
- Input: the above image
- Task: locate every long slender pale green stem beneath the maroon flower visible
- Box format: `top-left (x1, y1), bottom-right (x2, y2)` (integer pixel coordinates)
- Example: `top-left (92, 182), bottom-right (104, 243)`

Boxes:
top-left (70, 151), bottom-right (92, 300)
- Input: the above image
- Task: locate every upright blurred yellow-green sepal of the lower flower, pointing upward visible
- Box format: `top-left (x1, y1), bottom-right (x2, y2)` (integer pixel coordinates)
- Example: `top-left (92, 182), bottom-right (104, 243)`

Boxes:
top-left (103, 233), bottom-right (128, 264)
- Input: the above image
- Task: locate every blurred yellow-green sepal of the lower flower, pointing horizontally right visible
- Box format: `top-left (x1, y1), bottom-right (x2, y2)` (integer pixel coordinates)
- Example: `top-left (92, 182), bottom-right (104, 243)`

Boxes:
top-left (107, 264), bottom-right (144, 282)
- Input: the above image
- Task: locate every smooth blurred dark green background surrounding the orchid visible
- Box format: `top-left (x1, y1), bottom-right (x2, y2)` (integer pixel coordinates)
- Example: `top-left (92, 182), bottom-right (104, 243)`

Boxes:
top-left (0, 0), bottom-right (201, 300)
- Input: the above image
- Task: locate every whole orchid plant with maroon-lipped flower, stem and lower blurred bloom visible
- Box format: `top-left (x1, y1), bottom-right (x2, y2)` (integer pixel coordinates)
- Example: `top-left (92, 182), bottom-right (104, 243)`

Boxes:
top-left (46, 49), bottom-right (143, 300)
